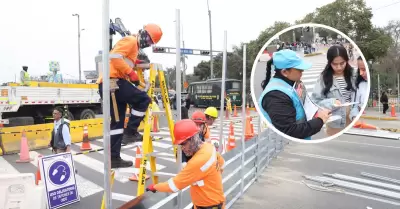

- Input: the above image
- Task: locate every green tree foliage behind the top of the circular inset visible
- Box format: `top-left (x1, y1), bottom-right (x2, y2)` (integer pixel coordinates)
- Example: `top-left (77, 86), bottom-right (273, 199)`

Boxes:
top-left (188, 0), bottom-right (400, 91)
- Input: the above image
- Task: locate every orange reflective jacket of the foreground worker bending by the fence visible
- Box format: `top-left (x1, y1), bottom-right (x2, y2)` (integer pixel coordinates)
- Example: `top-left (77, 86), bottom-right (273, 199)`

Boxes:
top-left (154, 143), bottom-right (225, 207)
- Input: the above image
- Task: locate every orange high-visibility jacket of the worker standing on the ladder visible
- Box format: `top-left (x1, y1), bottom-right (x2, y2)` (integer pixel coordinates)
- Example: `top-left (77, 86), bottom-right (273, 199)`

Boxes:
top-left (96, 36), bottom-right (139, 83)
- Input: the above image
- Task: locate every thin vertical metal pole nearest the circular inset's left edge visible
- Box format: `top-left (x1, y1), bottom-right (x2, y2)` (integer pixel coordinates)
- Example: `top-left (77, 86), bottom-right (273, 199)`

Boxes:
top-left (240, 45), bottom-right (247, 195)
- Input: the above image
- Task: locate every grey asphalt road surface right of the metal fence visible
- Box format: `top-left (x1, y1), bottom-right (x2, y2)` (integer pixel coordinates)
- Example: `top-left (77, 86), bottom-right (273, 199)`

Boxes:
top-left (232, 135), bottom-right (400, 209)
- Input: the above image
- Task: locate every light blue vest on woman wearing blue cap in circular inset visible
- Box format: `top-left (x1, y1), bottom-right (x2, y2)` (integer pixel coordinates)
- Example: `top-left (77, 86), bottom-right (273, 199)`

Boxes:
top-left (258, 78), bottom-right (311, 140)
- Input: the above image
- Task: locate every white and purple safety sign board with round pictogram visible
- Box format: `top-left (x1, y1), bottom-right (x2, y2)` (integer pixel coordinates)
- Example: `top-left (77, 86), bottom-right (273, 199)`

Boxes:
top-left (40, 153), bottom-right (80, 209)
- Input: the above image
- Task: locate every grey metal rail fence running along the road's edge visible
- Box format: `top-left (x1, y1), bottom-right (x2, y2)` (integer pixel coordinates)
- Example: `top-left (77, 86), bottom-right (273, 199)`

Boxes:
top-left (145, 119), bottom-right (289, 209)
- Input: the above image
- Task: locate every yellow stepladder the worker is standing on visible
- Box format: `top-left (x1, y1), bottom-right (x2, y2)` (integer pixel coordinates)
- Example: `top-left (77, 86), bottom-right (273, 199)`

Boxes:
top-left (136, 63), bottom-right (177, 196)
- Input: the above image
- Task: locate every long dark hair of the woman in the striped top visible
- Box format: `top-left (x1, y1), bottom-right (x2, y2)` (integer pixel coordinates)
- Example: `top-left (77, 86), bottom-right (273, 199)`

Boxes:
top-left (321, 45), bottom-right (354, 96)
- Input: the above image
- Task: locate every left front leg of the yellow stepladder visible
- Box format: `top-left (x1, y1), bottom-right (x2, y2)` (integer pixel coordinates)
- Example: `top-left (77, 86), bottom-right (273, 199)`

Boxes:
top-left (137, 64), bottom-right (156, 196)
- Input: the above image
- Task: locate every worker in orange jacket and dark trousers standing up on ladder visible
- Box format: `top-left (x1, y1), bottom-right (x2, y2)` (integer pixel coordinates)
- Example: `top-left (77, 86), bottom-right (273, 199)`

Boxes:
top-left (97, 24), bottom-right (163, 168)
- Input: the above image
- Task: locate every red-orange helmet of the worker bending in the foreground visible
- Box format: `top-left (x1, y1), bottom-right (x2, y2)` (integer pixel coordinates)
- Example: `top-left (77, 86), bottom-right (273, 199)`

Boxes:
top-left (174, 119), bottom-right (199, 145)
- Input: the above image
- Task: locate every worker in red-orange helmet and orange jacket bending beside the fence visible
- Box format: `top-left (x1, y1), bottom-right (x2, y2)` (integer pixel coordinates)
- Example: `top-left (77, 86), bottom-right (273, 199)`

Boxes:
top-left (146, 119), bottom-right (225, 209)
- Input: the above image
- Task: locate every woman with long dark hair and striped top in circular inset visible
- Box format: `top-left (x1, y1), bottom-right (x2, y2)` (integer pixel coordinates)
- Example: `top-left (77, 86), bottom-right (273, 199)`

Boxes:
top-left (311, 45), bottom-right (356, 136)
